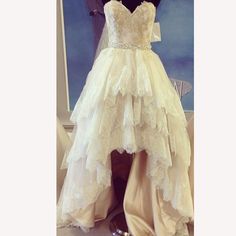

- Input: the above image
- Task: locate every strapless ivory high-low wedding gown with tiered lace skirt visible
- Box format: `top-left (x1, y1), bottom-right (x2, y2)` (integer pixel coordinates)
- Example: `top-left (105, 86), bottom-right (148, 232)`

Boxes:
top-left (57, 0), bottom-right (193, 236)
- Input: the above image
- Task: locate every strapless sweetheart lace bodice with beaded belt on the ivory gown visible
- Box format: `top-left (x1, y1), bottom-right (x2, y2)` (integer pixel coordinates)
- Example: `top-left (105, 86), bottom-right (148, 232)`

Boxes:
top-left (104, 0), bottom-right (156, 49)
